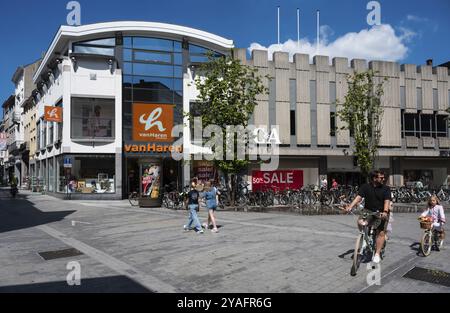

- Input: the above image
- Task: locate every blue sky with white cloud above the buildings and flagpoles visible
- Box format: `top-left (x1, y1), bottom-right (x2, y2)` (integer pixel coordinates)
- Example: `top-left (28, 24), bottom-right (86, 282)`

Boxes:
top-left (0, 0), bottom-right (450, 114)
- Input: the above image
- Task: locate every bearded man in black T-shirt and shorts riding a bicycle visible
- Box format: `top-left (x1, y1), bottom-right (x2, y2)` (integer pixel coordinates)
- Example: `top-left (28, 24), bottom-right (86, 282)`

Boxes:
top-left (346, 171), bottom-right (391, 263)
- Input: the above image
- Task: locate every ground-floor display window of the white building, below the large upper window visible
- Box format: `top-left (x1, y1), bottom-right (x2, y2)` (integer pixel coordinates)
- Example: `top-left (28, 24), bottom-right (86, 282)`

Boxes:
top-left (63, 155), bottom-right (116, 194)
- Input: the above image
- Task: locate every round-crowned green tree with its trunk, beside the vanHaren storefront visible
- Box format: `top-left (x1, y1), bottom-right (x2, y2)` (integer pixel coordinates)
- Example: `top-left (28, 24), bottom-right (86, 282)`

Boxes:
top-left (188, 53), bottom-right (269, 205)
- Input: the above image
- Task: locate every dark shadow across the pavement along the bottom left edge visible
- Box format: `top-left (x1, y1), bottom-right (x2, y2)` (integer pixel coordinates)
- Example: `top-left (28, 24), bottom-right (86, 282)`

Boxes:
top-left (0, 276), bottom-right (154, 293)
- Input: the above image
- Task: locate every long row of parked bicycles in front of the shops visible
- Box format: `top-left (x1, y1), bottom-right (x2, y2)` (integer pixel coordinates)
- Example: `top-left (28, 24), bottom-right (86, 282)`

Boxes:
top-left (162, 182), bottom-right (450, 210)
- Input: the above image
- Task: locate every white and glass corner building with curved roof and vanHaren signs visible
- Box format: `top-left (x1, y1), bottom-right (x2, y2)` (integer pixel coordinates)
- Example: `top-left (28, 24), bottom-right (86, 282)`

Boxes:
top-left (30, 22), bottom-right (233, 200)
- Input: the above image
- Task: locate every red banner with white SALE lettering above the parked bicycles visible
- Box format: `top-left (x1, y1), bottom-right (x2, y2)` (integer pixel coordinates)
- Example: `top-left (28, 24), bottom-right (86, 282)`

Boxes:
top-left (252, 170), bottom-right (303, 191)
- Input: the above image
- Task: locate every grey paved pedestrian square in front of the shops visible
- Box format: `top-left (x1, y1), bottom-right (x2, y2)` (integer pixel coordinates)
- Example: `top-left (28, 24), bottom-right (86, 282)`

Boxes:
top-left (0, 191), bottom-right (450, 293)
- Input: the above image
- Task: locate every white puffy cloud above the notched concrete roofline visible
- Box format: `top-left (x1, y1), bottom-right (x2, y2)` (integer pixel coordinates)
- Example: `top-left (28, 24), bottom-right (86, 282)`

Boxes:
top-left (248, 24), bottom-right (415, 61)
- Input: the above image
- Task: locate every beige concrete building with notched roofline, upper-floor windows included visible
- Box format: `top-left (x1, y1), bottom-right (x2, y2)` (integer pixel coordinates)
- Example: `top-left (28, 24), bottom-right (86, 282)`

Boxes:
top-left (232, 49), bottom-right (450, 187)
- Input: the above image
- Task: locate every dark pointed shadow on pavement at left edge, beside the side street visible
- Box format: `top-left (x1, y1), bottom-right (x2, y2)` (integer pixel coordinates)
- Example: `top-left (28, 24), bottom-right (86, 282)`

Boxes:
top-left (0, 190), bottom-right (76, 233)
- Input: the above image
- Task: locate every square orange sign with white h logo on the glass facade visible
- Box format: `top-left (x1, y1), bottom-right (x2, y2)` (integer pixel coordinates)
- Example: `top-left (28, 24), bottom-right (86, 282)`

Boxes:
top-left (133, 103), bottom-right (174, 142)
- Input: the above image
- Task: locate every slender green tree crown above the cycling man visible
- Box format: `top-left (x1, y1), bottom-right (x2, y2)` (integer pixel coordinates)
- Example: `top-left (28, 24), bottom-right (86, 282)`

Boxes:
top-left (336, 70), bottom-right (386, 176)
